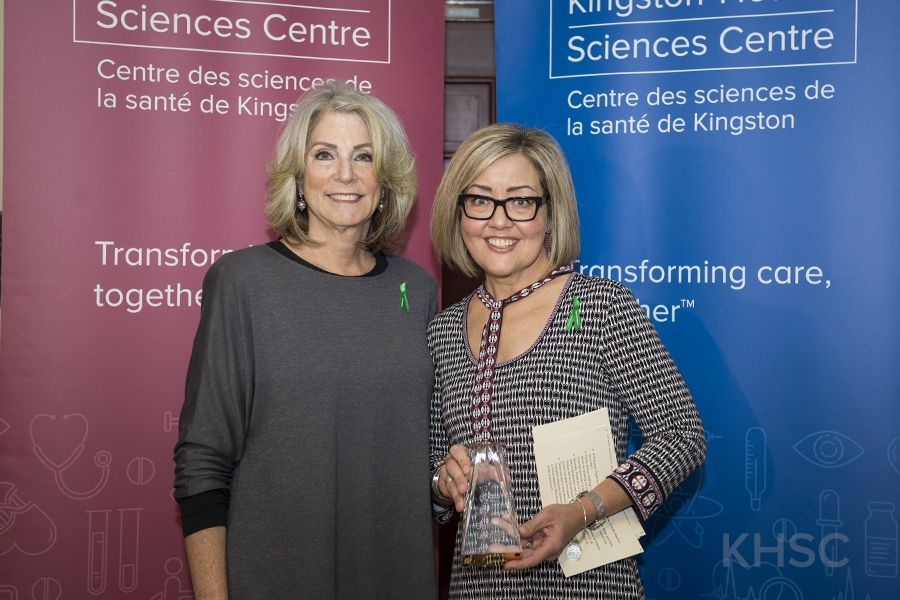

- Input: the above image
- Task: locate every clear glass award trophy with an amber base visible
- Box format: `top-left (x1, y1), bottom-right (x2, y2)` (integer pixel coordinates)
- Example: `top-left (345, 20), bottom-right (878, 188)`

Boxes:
top-left (460, 442), bottom-right (522, 567)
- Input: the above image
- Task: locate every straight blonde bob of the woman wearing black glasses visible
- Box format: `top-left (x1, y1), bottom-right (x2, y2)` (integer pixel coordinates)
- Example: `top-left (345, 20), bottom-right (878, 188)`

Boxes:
top-left (431, 124), bottom-right (581, 277)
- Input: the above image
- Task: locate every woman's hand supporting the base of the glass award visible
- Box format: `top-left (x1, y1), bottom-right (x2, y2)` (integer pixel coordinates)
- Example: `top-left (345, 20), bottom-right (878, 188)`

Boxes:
top-left (505, 500), bottom-right (584, 569)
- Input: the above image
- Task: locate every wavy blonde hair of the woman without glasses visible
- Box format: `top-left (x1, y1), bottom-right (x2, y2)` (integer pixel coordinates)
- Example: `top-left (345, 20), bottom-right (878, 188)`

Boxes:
top-left (266, 81), bottom-right (416, 252)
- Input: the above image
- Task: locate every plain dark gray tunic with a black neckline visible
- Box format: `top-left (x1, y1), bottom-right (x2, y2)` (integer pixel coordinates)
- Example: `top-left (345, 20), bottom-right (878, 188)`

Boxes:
top-left (175, 246), bottom-right (436, 600)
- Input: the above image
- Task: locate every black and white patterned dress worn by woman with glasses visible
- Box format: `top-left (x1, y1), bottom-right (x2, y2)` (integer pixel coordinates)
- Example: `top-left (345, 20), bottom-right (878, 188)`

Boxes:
top-left (428, 274), bottom-right (705, 600)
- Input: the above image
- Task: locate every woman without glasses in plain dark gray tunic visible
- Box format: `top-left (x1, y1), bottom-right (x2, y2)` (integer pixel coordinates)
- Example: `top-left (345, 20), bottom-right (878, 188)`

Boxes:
top-left (175, 83), bottom-right (436, 600)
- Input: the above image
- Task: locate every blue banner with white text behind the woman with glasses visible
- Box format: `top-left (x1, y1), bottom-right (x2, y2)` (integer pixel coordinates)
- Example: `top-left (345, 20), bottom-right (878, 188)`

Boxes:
top-left (494, 0), bottom-right (900, 600)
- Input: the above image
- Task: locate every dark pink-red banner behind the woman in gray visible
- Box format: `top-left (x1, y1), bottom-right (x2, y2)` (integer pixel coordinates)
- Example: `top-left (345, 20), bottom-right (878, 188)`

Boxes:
top-left (0, 0), bottom-right (443, 600)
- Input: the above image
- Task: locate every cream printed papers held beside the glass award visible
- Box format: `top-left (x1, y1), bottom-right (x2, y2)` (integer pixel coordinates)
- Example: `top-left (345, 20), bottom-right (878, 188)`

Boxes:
top-left (533, 408), bottom-right (644, 577)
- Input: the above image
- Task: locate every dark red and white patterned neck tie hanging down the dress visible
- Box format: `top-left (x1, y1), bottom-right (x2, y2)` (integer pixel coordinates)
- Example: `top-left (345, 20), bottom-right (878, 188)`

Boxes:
top-left (472, 266), bottom-right (572, 442)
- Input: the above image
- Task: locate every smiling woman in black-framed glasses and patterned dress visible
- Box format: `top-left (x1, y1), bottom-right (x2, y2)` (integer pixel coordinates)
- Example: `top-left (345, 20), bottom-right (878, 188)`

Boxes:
top-left (428, 125), bottom-right (705, 599)
